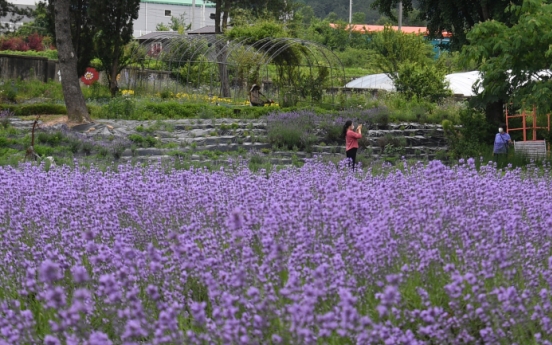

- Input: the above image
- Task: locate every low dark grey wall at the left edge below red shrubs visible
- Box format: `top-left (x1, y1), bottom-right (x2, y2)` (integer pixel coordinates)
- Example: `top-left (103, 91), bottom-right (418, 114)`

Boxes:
top-left (0, 54), bottom-right (59, 82)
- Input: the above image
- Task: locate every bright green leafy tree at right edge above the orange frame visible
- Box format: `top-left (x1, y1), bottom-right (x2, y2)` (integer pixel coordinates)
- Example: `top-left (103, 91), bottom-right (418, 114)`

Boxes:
top-left (462, 0), bottom-right (552, 123)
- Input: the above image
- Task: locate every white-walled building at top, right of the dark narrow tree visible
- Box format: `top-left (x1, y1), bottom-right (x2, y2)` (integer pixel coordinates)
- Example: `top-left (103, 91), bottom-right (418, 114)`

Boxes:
top-left (134, 0), bottom-right (215, 37)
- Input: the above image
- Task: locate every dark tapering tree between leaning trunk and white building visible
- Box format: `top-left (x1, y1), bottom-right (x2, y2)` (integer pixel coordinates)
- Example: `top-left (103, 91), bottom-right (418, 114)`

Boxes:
top-left (90, 0), bottom-right (140, 96)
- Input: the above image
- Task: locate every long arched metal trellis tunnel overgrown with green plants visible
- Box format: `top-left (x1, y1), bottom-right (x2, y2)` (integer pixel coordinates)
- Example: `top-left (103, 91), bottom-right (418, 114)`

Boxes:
top-left (127, 33), bottom-right (345, 103)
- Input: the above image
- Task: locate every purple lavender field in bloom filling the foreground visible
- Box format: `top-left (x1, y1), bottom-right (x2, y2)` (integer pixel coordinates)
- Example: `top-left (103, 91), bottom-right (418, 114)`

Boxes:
top-left (0, 160), bottom-right (552, 345)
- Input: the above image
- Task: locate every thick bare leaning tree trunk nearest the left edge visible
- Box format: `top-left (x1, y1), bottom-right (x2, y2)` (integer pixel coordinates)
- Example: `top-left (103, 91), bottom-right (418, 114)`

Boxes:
top-left (54, 0), bottom-right (91, 123)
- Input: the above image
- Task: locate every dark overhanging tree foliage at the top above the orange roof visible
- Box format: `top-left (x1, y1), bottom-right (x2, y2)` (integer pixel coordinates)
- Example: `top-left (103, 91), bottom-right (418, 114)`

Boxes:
top-left (371, 0), bottom-right (522, 48)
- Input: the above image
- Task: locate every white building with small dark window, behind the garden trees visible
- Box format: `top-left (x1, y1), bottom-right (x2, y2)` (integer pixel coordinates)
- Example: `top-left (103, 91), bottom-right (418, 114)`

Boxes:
top-left (133, 2), bottom-right (215, 37)
